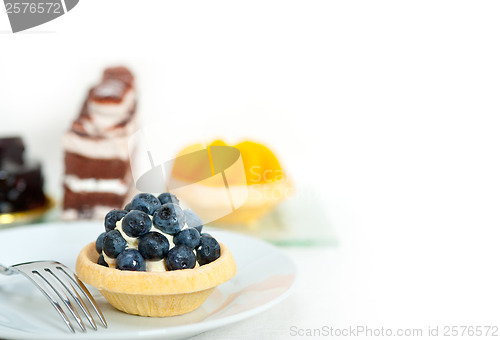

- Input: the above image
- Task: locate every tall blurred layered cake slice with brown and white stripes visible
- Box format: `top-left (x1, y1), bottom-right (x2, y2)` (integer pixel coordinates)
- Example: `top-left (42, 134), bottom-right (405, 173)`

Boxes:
top-left (62, 67), bottom-right (141, 220)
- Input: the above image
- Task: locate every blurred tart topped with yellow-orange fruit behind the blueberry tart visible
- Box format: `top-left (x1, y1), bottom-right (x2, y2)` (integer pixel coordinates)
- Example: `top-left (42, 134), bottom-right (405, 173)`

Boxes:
top-left (169, 140), bottom-right (294, 226)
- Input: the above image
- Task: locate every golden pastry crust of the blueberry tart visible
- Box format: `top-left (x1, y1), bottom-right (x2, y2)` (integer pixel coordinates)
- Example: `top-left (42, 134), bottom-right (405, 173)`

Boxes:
top-left (76, 242), bottom-right (236, 317)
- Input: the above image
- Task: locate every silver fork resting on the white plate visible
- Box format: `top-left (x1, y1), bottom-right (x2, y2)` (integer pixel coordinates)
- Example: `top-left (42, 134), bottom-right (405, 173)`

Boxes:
top-left (0, 261), bottom-right (108, 333)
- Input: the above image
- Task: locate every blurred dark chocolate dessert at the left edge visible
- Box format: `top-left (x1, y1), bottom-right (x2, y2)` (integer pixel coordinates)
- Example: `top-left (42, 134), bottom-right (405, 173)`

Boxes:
top-left (0, 137), bottom-right (47, 214)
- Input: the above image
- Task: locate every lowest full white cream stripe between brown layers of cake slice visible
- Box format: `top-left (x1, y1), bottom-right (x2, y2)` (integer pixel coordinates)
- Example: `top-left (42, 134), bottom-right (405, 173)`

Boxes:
top-left (64, 175), bottom-right (129, 195)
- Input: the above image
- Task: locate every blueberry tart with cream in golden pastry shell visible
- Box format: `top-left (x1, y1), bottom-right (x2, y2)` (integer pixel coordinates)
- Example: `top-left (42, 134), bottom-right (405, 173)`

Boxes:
top-left (76, 193), bottom-right (236, 317)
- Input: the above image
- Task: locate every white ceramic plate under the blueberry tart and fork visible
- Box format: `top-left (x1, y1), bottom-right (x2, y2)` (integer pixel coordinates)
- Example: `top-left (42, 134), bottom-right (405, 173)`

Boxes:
top-left (0, 222), bottom-right (296, 339)
